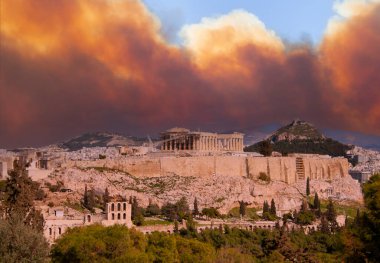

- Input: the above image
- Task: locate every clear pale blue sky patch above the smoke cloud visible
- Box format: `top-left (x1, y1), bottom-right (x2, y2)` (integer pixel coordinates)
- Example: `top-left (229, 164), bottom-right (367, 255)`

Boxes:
top-left (144, 0), bottom-right (335, 43)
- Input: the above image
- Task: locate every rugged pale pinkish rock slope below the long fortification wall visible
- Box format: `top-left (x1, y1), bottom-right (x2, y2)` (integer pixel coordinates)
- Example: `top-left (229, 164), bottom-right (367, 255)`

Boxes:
top-left (44, 167), bottom-right (362, 216)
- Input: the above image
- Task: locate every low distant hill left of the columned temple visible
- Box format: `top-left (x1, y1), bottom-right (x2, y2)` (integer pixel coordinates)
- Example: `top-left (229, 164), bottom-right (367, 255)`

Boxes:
top-left (58, 132), bottom-right (146, 151)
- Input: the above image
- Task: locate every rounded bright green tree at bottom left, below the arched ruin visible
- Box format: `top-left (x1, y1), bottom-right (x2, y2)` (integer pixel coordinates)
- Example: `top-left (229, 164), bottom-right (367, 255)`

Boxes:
top-left (51, 225), bottom-right (151, 262)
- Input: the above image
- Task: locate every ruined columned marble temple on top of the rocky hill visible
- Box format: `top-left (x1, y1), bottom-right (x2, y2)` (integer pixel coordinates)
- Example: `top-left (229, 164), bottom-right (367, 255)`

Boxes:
top-left (161, 128), bottom-right (244, 152)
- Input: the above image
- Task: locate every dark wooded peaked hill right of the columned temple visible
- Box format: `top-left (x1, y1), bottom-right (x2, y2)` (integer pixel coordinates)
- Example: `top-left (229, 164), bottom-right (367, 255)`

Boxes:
top-left (244, 120), bottom-right (352, 156)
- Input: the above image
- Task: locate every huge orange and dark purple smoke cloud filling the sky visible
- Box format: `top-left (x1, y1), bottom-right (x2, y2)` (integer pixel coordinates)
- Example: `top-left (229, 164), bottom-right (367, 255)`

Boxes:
top-left (0, 0), bottom-right (380, 148)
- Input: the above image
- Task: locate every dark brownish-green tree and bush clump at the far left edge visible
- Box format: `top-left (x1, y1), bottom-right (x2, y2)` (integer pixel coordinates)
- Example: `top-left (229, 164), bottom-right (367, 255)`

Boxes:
top-left (0, 162), bottom-right (49, 263)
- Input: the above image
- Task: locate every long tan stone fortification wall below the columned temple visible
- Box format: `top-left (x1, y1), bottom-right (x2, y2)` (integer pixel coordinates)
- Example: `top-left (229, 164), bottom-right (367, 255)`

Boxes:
top-left (66, 156), bottom-right (348, 184)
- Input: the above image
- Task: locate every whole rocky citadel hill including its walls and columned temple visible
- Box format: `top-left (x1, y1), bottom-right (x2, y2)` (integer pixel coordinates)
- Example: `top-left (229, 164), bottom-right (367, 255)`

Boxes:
top-left (0, 128), bottom-right (361, 220)
